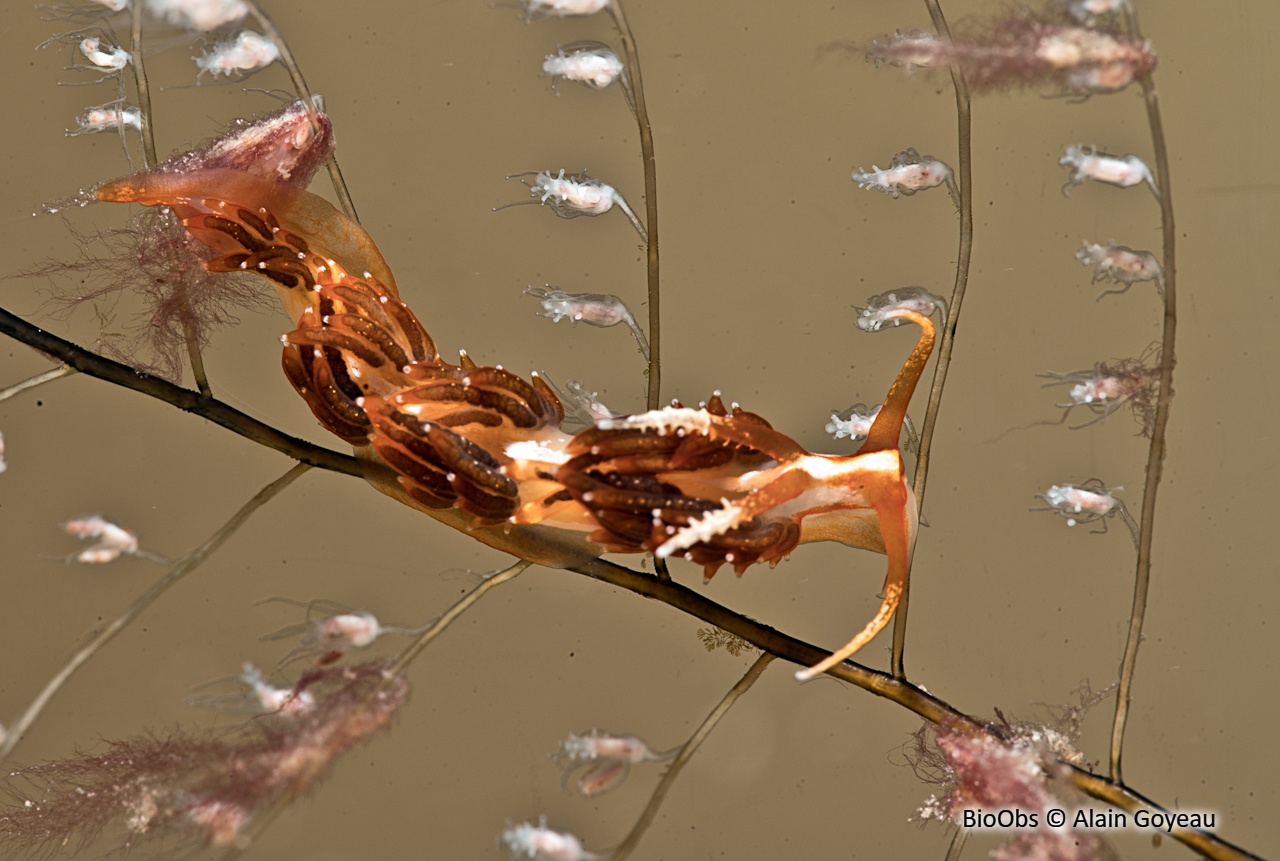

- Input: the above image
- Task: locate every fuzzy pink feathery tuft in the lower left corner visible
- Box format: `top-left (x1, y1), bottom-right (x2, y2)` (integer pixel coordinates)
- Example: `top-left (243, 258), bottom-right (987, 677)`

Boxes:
top-left (0, 661), bottom-right (410, 855)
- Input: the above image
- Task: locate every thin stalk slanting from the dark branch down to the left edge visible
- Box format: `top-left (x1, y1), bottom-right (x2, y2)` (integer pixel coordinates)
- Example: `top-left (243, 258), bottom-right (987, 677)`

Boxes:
top-left (0, 463), bottom-right (311, 760)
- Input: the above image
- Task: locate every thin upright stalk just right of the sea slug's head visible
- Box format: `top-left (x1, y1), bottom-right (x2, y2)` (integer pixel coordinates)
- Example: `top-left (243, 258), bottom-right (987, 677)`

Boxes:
top-left (890, 0), bottom-right (973, 678)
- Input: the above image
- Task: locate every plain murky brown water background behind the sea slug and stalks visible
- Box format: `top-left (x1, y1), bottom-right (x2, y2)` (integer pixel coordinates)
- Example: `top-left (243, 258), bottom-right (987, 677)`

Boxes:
top-left (0, 0), bottom-right (1280, 861)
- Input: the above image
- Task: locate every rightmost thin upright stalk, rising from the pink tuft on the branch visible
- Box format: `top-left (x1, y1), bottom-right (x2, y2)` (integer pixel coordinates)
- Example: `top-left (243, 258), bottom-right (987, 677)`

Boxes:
top-left (1110, 10), bottom-right (1178, 783)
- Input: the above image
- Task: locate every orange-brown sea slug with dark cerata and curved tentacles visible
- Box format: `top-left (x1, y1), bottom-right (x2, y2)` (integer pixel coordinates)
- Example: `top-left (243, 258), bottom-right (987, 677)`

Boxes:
top-left (96, 115), bottom-right (934, 675)
